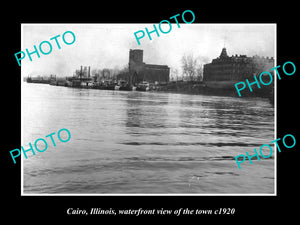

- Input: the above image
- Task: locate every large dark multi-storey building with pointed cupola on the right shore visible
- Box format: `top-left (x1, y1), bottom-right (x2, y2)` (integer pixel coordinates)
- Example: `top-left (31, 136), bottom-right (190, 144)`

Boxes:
top-left (203, 48), bottom-right (274, 81)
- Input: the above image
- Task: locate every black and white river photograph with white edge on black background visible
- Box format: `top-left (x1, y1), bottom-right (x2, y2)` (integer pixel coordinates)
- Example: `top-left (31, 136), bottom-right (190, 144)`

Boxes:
top-left (20, 23), bottom-right (276, 196)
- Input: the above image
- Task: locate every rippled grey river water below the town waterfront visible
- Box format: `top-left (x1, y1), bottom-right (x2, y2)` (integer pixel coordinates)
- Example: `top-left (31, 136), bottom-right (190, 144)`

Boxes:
top-left (22, 83), bottom-right (275, 194)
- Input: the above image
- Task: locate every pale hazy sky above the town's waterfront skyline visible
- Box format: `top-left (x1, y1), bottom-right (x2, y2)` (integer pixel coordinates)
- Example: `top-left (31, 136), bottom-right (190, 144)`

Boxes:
top-left (20, 23), bottom-right (276, 77)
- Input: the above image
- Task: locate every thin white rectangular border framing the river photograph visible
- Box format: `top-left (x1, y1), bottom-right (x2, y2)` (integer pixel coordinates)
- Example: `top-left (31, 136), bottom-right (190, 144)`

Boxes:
top-left (21, 23), bottom-right (277, 196)
